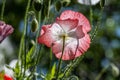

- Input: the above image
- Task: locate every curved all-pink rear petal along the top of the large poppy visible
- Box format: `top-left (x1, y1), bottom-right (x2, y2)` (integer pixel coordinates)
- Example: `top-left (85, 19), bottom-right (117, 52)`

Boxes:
top-left (60, 10), bottom-right (91, 32)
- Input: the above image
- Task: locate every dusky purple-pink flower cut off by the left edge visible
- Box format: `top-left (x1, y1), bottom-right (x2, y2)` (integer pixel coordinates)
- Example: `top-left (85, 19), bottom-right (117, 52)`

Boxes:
top-left (0, 21), bottom-right (14, 43)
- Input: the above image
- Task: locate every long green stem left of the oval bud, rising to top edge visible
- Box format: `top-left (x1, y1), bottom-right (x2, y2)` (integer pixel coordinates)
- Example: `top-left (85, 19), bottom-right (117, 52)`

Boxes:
top-left (19, 0), bottom-right (31, 77)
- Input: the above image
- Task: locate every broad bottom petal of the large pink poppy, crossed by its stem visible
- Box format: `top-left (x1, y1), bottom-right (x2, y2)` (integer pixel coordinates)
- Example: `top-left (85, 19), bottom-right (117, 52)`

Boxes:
top-left (52, 34), bottom-right (90, 60)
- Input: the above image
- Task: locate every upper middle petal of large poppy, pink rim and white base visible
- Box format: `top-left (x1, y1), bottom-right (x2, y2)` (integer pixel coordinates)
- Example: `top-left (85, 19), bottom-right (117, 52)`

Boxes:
top-left (56, 18), bottom-right (78, 32)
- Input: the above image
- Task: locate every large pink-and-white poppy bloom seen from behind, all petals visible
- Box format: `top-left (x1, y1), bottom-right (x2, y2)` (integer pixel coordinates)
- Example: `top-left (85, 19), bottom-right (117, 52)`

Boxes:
top-left (38, 10), bottom-right (91, 60)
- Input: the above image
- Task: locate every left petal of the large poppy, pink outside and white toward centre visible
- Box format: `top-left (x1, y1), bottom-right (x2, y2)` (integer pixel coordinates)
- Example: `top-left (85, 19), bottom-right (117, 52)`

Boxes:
top-left (38, 23), bottom-right (63, 47)
